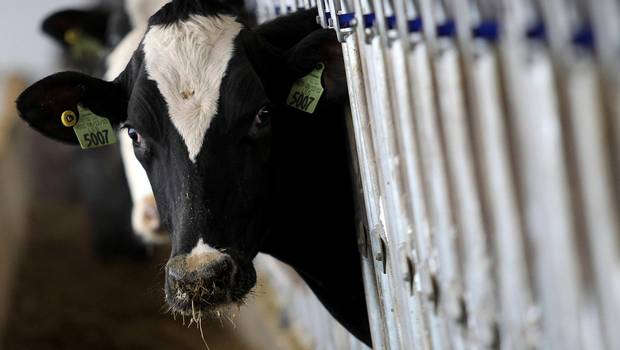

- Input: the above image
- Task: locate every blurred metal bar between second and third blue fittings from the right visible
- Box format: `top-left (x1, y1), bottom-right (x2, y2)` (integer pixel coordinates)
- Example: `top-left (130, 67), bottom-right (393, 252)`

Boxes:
top-left (501, 1), bottom-right (583, 349)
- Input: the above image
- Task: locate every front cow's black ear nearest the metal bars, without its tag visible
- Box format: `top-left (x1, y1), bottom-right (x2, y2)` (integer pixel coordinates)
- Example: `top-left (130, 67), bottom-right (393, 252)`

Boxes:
top-left (285, 29), bottom-right (347, 103)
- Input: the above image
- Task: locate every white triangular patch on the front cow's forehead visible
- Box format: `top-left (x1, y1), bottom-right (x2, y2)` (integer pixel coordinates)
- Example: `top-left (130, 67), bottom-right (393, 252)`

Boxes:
top-left (143, 15), bottom-right (242, 162)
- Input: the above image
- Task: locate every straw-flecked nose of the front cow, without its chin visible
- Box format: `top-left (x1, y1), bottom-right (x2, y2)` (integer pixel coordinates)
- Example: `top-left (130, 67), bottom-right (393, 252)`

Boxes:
top-left (166, 252), bottom-right (235, 306)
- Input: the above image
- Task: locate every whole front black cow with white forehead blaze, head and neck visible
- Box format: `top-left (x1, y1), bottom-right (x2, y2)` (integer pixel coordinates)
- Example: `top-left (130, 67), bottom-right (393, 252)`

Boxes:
top-left (17, 0), bottom-right (370, 344)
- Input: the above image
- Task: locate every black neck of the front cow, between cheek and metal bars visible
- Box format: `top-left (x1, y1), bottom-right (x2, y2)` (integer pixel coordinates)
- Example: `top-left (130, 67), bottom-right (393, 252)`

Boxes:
top-left (263, 103), bottom-right (370, 344)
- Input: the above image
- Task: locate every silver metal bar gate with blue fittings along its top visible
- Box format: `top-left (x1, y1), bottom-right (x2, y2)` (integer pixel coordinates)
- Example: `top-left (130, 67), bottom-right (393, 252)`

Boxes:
top-left (251, 0), bottom-right (620, 350)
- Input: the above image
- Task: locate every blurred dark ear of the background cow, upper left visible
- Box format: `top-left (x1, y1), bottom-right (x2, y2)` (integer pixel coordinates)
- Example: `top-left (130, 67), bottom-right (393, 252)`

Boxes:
top-left (41, 8), bottom-right (110, 48)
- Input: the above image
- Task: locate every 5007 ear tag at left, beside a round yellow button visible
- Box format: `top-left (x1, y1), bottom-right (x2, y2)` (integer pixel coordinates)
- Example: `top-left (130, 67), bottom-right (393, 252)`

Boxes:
top-left (73, 105), bottom-right (116, 149)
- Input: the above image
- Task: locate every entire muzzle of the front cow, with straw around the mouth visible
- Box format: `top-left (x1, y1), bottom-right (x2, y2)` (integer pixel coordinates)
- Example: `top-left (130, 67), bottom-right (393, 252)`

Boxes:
top-left (165, 247), bottom-right (256, 320)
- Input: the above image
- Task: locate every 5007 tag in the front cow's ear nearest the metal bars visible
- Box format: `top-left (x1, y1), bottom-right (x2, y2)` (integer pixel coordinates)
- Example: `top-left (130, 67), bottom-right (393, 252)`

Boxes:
top-left (286, 63), bottom-right (325, 113)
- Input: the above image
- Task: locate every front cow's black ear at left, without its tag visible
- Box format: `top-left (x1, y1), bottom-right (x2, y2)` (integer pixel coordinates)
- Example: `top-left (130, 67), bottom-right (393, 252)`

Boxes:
top-left (16, 72), bottom-right (127, 144)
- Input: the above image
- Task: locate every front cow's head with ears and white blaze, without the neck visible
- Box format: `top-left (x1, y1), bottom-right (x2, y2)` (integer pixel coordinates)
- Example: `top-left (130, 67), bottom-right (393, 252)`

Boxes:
top-left (17, 0), bottom-right (346, 316)
